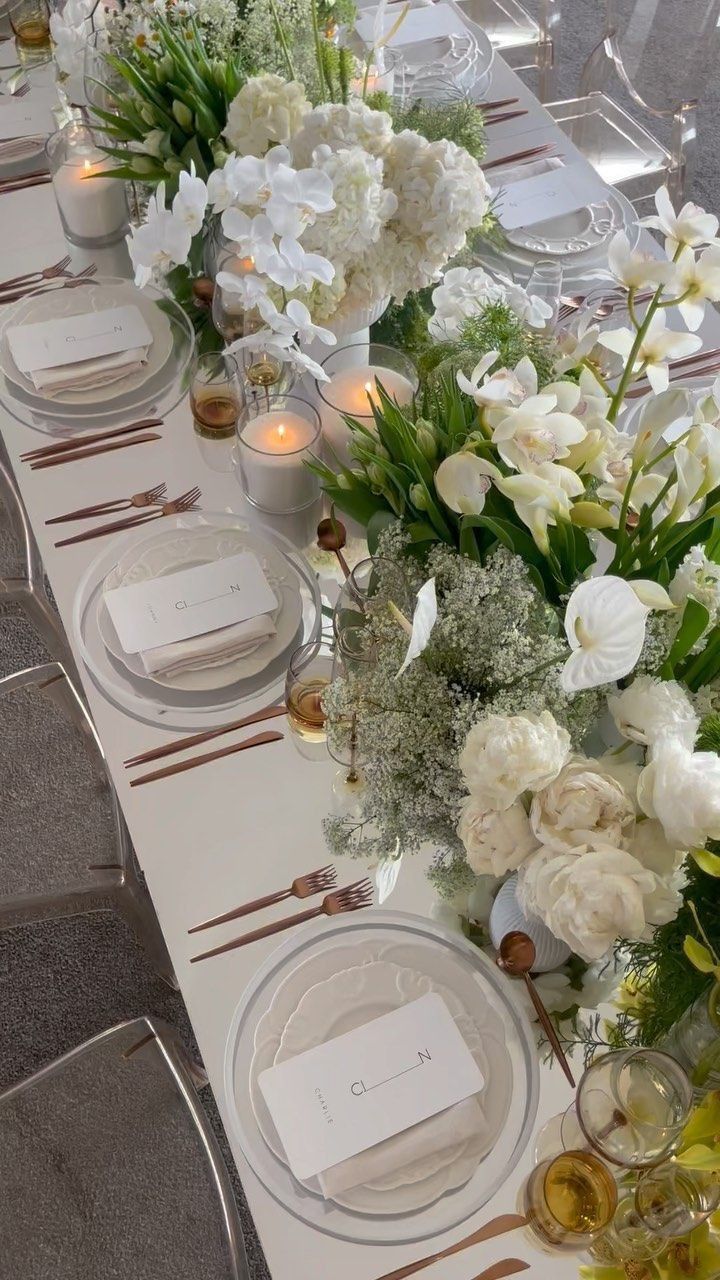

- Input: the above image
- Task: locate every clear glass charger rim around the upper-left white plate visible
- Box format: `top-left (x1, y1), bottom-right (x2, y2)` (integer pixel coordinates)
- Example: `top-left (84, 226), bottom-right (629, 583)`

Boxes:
top-left (0, 276), bottom-right (195, 436)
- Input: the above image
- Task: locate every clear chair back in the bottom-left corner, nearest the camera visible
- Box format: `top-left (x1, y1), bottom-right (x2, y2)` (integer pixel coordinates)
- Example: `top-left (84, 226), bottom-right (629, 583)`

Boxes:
top-left (0, 1018), bottom-right (249, 1280)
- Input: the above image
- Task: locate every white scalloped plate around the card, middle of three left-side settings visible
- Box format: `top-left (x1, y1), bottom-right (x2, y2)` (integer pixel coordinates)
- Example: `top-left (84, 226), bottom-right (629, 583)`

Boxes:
top-left (97, 529), bottom-right (302, 692)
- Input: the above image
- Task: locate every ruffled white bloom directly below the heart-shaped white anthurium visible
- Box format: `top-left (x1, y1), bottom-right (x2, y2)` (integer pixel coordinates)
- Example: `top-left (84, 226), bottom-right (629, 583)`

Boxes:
top-left (607, 676), bottom-right (700, 750)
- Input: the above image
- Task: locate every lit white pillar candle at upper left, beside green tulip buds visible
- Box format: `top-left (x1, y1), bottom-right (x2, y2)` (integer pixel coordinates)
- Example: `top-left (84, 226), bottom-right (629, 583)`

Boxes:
top-left (53, 142), bottom-right (128, 244)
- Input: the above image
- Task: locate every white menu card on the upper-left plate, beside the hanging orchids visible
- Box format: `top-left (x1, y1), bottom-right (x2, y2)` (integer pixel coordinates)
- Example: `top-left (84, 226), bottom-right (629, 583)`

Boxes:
top-left (8, 305), bottom-right (152, 374)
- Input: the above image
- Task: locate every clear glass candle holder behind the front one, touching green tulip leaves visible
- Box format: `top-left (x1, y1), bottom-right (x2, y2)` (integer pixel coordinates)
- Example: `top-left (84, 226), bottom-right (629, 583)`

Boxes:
top-left (315, 342), bottom-right (418, 466)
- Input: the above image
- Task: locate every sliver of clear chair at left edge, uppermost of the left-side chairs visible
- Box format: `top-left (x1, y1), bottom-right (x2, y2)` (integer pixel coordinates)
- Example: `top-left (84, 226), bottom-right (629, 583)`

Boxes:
top-left (0, 449), bottom-right (74, 672)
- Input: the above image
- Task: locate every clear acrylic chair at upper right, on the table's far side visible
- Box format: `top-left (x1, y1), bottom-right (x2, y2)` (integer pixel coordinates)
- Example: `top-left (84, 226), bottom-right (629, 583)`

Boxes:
top-left (547, 0), bottom-right (720, 204)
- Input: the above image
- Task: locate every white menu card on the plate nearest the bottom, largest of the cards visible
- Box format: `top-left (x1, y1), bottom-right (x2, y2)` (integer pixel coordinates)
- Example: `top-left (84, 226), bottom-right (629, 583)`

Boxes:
top-left (258, 992), bottom-right (484, 1178)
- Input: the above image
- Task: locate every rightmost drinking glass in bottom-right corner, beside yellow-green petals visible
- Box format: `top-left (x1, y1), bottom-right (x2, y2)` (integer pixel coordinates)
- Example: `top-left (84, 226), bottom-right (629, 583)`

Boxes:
top-left (635, 1160), bottom-right (720, 1240)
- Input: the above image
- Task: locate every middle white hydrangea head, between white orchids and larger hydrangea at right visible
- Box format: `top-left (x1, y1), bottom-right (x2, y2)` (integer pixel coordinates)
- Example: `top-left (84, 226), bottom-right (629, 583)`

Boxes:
top-left (304, 145), bottom-right (397, 268)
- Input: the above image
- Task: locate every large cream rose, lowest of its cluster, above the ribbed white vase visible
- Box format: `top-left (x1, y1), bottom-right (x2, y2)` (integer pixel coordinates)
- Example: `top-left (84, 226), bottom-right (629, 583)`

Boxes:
top-left (518, 844), bottom-right (666, 960)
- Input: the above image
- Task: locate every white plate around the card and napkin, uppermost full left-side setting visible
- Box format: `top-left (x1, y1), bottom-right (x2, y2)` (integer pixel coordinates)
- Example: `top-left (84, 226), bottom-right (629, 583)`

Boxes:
top-left (0, 280), bottom-right (173, 410)
